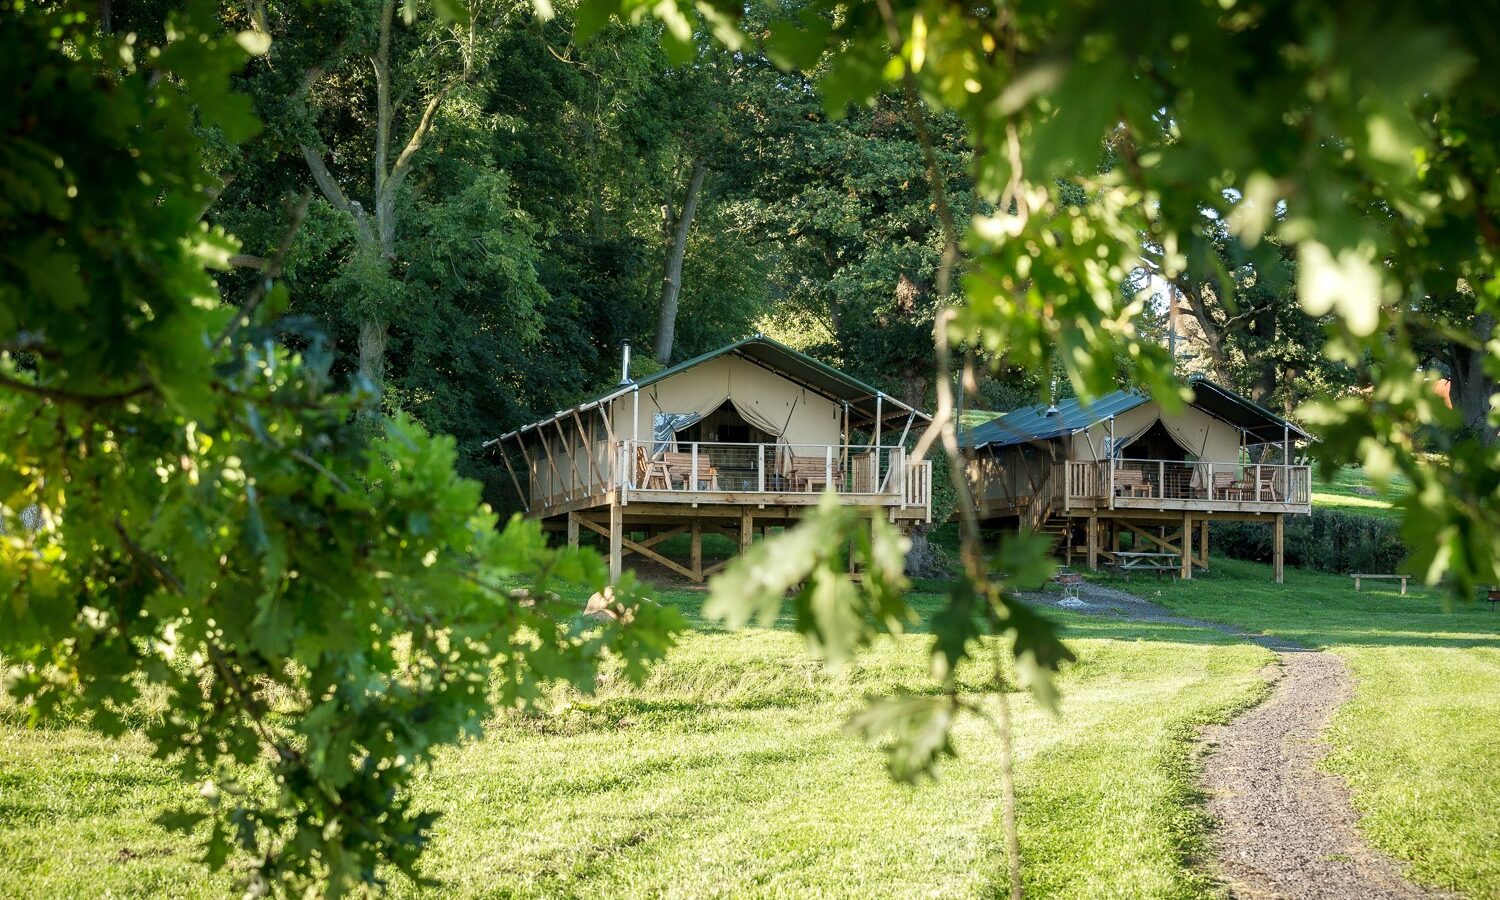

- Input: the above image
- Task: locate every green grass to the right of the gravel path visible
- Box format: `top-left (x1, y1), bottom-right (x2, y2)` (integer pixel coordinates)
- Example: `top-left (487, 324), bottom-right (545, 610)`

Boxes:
top-left (1104, 561), bottom-right (1500, 897)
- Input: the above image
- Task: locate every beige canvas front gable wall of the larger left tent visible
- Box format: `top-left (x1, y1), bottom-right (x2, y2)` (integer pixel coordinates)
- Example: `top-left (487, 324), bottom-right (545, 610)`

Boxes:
top-left (614, 354), bottom-right (843, 444)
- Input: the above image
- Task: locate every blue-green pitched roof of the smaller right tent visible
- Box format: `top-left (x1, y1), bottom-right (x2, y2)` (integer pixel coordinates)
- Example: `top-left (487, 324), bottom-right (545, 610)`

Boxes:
top-left (959, 377), bottom-right (1311, 450)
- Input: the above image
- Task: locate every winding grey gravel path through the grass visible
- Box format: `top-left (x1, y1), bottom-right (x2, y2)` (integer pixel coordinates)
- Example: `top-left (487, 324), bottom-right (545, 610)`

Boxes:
top-left (1026, 585), bottom-right (1446, 900)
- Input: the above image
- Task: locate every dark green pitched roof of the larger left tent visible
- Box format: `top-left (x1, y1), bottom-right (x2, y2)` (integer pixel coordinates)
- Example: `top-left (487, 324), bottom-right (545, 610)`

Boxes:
top-left (485, 335), bottom-right (932, 447)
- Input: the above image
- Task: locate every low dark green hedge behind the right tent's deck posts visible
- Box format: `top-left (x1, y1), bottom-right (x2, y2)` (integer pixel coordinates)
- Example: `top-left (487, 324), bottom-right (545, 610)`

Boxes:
top-left (1209, 509), bottom-right (1407, 573)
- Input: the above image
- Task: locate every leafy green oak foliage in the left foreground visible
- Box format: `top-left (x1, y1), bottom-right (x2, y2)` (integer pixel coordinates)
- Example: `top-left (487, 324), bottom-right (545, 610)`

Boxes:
top-left (0, 5), bottom-right (680, 896)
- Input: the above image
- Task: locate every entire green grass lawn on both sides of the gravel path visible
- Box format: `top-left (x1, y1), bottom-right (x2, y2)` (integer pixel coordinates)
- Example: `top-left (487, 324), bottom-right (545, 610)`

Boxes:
top-left (0, 563), bottom-right (1500, 897)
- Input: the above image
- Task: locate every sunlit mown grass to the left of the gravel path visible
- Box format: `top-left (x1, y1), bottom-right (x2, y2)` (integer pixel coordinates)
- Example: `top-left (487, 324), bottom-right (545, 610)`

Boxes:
top-left (0, 591), bottom-right (1269, 897)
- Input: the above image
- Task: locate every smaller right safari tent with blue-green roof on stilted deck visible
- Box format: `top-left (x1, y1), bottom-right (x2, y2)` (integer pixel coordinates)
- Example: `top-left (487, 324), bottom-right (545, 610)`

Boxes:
top-left (960, 378), bottom-right (1311, 579)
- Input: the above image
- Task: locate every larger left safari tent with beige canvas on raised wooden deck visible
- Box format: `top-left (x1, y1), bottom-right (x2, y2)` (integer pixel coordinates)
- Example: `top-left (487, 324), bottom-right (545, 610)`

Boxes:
top-left (488, 335), bottom-right (932, 581)
